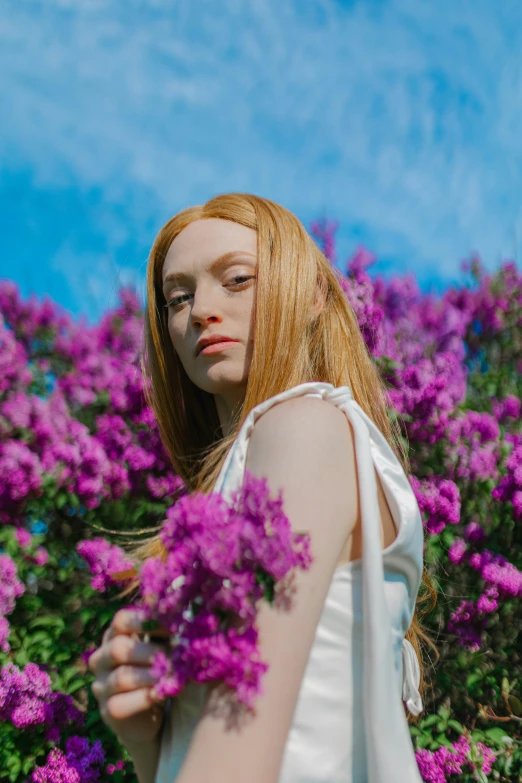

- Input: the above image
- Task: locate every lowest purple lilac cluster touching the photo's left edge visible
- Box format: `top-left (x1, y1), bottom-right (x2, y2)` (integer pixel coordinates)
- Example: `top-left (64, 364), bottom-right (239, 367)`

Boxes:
top-left (0, 663), bottom-right (84, 742)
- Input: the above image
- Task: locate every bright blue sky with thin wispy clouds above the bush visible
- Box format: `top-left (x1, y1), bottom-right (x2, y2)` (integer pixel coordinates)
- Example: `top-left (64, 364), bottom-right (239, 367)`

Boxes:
top-left (0, 0), bottom-right (522, 320)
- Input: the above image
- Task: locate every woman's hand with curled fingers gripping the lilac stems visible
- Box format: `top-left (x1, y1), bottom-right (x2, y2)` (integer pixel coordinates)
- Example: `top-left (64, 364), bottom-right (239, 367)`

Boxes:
top-left (88, 609), bottom-right (168, 749)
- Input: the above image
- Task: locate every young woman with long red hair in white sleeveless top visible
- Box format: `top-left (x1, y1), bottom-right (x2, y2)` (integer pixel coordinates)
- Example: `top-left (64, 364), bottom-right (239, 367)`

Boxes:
top-left (90, 193), bottom-right (434, 783)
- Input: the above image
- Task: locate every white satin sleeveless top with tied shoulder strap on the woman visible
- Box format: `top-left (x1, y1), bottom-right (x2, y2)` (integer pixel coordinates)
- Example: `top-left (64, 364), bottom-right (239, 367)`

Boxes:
top-left (155, 381), bottom-right (423, 783)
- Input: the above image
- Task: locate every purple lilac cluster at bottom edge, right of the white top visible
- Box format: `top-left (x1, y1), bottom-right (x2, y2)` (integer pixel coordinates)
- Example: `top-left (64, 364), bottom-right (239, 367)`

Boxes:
top-left (415, 735), bottom-right (496, 783)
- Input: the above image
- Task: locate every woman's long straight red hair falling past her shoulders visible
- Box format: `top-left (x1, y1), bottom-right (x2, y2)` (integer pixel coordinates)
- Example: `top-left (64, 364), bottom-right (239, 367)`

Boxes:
top-left (123, 193), bottom-right (439, 722)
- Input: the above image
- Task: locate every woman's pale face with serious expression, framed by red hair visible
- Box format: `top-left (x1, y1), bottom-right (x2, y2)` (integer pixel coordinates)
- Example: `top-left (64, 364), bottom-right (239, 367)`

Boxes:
top-left (162, 218), bottom-right (257, 422)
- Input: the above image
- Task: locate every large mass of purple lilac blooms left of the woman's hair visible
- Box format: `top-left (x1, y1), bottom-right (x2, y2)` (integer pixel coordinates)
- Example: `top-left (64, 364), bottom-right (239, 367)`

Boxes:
top-left (0, 282), bottom-right (183, 524)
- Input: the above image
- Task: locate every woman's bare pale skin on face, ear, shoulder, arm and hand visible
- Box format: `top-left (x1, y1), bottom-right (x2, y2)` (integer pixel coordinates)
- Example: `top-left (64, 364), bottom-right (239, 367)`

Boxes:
top-left (89, 218), bottom-right (396, 783)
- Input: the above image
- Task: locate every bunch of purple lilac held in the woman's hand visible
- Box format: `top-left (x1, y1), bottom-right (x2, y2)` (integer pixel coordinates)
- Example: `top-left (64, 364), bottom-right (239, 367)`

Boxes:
top-left (135, 472), bottom-right (311, 708)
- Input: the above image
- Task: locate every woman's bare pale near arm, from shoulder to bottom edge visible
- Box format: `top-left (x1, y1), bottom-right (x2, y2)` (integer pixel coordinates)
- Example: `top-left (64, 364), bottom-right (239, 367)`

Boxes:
top-left (173, 397), bottom-right (357, 783)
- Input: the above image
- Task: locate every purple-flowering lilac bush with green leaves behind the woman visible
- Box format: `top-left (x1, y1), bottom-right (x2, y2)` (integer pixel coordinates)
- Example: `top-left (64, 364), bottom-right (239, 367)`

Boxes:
top-left (0, 222), bottom-right (522, 783)
